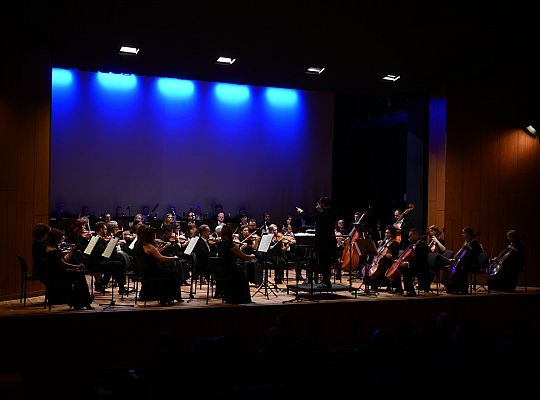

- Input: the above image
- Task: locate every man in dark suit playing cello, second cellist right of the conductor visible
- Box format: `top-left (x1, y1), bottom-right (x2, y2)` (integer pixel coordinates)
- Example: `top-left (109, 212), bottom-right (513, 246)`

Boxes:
top-left (396, 228), bottom-right (431, 297)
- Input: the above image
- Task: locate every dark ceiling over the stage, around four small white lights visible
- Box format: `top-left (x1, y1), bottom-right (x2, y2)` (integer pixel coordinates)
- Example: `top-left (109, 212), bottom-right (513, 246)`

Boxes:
top-left (5, 1), bottom-right (536, 96)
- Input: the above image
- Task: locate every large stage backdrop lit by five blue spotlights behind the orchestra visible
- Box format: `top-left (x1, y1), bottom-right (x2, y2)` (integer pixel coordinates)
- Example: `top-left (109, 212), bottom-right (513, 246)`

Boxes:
top-left (51, 69), bottom-right (334, 222)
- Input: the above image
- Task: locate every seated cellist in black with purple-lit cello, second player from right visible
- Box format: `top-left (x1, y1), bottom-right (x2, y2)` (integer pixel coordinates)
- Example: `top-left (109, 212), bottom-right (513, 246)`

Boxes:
top-left (445, 226), bottom-right (484, 294)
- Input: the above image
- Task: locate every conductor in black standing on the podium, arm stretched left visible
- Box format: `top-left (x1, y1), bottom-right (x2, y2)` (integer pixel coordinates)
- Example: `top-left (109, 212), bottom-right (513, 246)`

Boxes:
top-left (296, 196), bottom-right (337, 288)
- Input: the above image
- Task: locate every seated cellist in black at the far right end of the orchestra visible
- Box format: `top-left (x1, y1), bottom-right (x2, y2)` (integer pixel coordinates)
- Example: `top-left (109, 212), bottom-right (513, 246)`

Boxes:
top-left (488, 229), bottom-right (525, 292)
